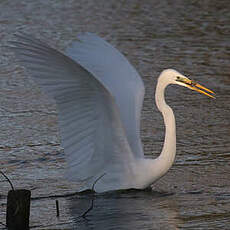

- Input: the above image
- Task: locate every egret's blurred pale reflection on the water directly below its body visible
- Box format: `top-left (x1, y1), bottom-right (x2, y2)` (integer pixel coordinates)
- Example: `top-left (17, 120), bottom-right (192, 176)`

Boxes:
top-left (69, 190), bottom-right (180, 230)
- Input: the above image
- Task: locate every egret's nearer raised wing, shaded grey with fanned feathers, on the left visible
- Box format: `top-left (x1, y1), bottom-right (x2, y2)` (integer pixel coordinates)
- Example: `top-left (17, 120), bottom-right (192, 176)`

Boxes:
top-left (11, 35), bottom-right (133, 185)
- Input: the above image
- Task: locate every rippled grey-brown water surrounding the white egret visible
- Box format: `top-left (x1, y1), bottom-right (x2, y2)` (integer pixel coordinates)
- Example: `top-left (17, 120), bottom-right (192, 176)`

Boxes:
top-left (0, 0), bottom-right (230, 229)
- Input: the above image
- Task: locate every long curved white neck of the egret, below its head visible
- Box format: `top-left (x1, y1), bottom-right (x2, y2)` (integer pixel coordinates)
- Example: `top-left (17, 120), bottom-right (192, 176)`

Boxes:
top-left (153, 77), bottom-right (176, 178)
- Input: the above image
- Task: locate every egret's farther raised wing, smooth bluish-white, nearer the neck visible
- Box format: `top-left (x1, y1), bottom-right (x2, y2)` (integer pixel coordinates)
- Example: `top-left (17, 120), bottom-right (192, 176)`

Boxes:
top-left (66, 33), bottom-right (145, 157)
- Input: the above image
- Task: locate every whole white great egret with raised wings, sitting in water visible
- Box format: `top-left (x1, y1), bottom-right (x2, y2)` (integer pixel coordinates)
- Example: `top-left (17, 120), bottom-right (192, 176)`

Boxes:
top-left (8, 33), bottom-right (214, 192)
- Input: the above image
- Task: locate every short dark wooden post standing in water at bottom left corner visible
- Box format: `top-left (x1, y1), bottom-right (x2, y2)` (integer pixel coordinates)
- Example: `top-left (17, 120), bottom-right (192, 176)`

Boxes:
top-left (6, 189), bottom-right (31, 230)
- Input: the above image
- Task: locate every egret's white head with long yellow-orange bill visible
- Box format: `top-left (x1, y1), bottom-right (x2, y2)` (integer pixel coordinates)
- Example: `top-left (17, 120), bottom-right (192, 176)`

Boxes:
top-left (161, 69), bottom-right (215, 98)
